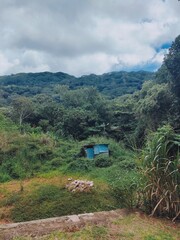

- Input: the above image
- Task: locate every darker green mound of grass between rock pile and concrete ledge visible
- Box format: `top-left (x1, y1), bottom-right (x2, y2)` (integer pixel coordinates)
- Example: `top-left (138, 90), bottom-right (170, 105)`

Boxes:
top-left (9, 185), bottom-right (118, 222)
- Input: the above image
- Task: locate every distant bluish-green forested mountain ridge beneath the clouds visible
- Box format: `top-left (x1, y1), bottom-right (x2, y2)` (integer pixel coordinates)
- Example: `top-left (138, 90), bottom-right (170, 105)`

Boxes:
top-left (0, 71), bottom-right (155, 102)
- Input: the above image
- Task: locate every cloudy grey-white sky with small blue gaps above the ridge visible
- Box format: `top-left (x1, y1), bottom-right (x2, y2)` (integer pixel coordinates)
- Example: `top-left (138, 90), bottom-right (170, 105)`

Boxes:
top-left (0, 0), bottom-right (180, 76)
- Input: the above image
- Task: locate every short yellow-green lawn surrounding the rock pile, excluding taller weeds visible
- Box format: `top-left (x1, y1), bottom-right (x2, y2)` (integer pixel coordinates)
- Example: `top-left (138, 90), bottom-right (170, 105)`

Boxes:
top-left (0, 171), bottom-right (120, 222)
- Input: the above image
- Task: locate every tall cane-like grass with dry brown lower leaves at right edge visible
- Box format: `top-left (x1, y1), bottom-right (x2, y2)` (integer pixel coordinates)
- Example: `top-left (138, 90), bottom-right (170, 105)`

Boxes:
top-left (144, 126), bottom-right (180, 220)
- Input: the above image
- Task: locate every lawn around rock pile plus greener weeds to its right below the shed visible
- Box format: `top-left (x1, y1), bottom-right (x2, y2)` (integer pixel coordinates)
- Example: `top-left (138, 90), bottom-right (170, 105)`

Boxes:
top-left (0, 157), bottom-right (139, 222)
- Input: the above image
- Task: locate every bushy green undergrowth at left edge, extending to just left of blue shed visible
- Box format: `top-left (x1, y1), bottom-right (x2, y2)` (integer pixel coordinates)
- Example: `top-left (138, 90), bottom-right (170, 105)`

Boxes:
top-left (0, 126), bottom-right (72, 182)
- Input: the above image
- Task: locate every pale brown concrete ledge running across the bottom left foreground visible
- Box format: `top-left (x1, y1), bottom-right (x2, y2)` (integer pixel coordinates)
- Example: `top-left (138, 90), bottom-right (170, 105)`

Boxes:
top-left (0, 209), bottom-right (129, 240)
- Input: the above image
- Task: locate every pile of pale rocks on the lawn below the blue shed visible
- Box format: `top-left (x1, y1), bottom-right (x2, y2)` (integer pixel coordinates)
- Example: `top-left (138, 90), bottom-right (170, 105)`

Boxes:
top-left (66, 180), bottom-right (94, 192)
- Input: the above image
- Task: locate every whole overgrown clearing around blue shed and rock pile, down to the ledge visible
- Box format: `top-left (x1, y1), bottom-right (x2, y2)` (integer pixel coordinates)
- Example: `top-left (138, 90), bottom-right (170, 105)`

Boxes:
top-left (0, 134), bottom-right (138, 222)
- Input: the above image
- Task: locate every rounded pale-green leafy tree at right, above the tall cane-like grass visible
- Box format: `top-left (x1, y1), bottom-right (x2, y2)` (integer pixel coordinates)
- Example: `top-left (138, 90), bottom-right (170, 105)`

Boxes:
top-left (134, 82), bottom-right (173, 131)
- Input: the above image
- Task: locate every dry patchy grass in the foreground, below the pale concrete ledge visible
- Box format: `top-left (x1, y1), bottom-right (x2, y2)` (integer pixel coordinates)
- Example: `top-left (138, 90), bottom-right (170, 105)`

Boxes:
top-left (13, 214), bottom-right (180, 240)
